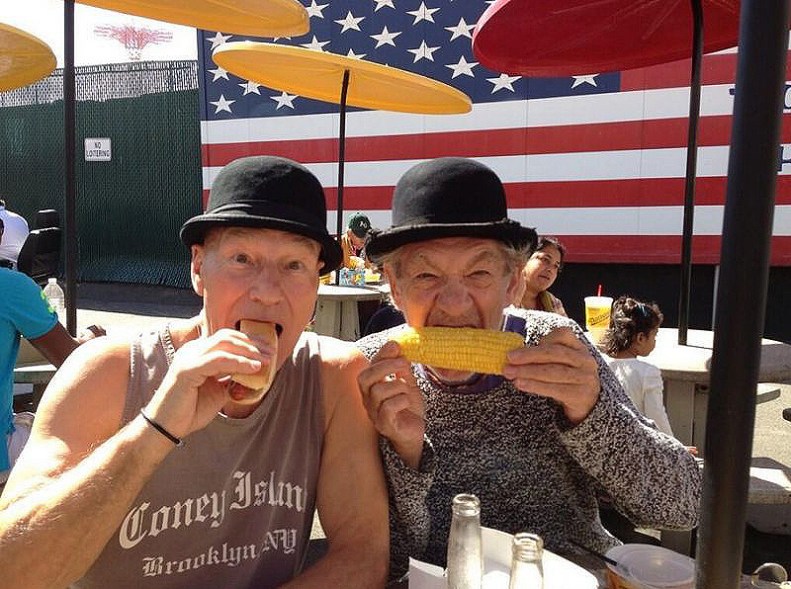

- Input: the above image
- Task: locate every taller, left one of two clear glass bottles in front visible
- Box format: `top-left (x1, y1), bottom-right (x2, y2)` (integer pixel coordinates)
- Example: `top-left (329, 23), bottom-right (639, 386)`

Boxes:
top-left (448, 494), bottom-right (483, 589)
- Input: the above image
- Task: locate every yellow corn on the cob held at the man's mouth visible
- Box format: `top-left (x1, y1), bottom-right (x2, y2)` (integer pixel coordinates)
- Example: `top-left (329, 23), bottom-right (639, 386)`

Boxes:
top-left (393, 327), bottom-right (524, 374)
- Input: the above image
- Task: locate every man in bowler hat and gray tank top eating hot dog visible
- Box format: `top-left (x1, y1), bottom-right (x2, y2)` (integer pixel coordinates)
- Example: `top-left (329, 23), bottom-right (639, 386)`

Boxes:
top-left (0, 157), bottom-right (388, 589)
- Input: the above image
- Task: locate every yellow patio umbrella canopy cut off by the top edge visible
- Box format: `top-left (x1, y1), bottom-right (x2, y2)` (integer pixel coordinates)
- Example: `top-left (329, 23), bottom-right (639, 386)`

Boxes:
top-left (78, 0), bottom-right (310, 37)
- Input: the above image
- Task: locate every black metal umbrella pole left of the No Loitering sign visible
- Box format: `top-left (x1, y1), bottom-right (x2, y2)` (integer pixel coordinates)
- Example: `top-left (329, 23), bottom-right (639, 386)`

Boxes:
top-left (63, 0), bottom-right (77, 336)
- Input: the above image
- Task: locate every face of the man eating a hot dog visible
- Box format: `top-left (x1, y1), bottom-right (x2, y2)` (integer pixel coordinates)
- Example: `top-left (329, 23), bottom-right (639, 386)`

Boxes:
top-left (191, 227), bottom-right (323, 368)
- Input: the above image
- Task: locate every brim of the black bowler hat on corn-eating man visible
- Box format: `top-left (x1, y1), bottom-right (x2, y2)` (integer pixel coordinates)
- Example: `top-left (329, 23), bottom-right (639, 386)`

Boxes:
top-left (365, 219), bottom-right (538, 262)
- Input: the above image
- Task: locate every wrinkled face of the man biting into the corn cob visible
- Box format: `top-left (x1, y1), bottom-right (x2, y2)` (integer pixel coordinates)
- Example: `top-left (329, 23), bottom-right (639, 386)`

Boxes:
top-left (385, 237), bottom-right (519, 380)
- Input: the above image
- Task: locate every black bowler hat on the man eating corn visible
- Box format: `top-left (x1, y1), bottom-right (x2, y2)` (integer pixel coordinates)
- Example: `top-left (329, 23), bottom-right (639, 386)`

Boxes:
top-left (365, 157), bottom-right (536, 260)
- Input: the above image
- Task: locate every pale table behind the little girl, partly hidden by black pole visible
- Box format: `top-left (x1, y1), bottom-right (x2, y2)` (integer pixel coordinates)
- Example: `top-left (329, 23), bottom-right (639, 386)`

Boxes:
top-left (645, 328), bottom-right (791, 455)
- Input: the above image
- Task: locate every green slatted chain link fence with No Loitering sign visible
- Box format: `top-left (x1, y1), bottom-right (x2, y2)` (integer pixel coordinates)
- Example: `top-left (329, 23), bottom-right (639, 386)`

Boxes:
top-left (0, 61), bottom-right (202, 287)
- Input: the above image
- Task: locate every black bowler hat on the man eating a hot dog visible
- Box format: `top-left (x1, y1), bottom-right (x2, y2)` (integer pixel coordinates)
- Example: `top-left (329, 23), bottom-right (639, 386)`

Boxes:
top-left (180, 156), bottom-right (343, 274)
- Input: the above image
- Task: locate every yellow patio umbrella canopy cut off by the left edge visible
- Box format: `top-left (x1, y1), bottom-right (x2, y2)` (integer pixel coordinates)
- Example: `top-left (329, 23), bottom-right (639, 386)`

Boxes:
top-left (0, 23), bottom-right (56, 92)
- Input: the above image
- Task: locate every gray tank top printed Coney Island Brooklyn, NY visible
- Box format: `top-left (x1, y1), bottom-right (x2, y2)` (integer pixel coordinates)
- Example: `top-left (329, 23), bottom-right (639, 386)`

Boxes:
top-left (74, 328), bottom-right (324, 589)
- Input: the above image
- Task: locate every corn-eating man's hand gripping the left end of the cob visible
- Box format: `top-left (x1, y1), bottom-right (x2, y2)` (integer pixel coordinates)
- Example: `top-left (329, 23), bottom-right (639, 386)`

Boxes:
top-left (357, 342), bottom-right (426, 468)
